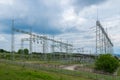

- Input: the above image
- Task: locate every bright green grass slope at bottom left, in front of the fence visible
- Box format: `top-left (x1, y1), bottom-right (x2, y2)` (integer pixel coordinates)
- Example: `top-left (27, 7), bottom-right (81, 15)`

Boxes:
top-left (0, 63), bottom-right (90, 80)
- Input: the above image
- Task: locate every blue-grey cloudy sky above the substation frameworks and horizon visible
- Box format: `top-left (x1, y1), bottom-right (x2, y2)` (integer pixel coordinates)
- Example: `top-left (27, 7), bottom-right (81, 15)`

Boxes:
top-left (0, 0), bottom-right (120, 53)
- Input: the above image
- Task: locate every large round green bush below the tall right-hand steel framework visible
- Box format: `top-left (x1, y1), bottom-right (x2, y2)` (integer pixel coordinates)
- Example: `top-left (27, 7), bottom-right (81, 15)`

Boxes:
top-left (95, 54), bottom-right (119, 73)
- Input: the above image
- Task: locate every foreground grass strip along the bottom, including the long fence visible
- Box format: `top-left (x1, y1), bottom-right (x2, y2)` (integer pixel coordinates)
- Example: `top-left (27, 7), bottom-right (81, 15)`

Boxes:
top-left (0, 60), bottom-right (120, 80)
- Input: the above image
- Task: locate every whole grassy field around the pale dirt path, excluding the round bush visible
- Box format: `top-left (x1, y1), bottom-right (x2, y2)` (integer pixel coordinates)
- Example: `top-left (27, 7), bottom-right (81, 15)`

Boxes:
top-left (0, 54), bottom-right (120, 80)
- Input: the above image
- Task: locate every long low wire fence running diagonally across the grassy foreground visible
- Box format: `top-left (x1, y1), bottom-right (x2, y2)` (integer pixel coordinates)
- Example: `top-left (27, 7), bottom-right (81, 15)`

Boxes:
top-left (0, 59), bottom-right (120, 80)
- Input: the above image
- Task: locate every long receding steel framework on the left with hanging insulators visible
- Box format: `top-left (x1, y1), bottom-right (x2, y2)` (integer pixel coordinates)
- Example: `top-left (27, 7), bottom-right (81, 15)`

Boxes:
top-left (11, 20), bottom-right (73, 60)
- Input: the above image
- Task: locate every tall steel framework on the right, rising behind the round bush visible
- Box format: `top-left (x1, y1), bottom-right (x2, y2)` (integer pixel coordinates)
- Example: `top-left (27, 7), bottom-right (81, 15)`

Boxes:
top-left (96, 20), bottom-right (113, 54)
